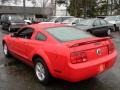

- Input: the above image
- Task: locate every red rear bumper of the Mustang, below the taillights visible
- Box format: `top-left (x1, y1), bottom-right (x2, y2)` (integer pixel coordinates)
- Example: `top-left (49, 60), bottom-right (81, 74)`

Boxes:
top-left (62, 51), bottom-right (117, 82)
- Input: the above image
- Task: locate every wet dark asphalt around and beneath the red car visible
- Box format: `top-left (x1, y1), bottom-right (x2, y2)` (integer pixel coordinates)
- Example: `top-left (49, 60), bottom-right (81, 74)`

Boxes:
top-left (0, 30), bottom-right (120, 90)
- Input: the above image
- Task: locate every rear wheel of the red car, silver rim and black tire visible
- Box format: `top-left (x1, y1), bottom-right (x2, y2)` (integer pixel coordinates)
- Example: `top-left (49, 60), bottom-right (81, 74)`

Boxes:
top-left (35, 58), bottom-right (51, 84)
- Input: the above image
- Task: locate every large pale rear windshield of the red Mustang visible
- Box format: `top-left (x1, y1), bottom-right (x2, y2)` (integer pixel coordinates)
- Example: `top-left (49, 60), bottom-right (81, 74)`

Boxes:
top-left (46, 27), bottom-right (93, 42)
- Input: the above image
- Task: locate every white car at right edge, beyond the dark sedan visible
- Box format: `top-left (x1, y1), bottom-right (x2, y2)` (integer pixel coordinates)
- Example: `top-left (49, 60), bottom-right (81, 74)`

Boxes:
top-left (105, 15), bottom-right (120, 31)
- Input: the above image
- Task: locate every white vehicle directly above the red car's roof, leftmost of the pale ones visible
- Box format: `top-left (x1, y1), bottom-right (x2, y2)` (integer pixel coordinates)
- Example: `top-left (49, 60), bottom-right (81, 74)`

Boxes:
top-left (46, 16), bottom-right (73, 23)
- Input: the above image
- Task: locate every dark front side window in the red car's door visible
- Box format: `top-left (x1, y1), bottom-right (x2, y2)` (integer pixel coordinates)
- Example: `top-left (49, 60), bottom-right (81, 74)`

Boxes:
top-left (17, 28), bottom-right (34, 39)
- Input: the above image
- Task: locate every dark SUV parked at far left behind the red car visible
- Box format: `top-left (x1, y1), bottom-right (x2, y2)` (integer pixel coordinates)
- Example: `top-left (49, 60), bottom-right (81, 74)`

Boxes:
top-left (1, 15), bottom-right (26, 32)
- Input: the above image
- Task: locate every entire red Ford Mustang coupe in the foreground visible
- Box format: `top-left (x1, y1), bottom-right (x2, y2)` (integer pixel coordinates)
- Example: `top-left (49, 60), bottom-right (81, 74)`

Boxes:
top-left (3, 23), bottom-right (117, 84)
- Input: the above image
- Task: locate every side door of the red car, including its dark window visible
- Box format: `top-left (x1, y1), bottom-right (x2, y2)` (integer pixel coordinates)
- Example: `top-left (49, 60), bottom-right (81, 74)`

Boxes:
top-left (11, 28), bottom-right (33, 59)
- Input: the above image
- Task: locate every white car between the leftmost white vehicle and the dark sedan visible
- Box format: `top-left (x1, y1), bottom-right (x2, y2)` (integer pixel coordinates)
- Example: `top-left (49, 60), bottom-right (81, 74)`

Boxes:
top-left (62, 18), bottom-right (84, 25)
